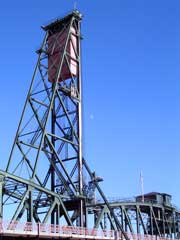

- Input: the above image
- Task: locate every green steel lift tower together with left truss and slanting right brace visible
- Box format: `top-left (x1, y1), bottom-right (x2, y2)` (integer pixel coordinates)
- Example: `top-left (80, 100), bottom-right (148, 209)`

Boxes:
top-left (0, 11), bottom-right (127, 238)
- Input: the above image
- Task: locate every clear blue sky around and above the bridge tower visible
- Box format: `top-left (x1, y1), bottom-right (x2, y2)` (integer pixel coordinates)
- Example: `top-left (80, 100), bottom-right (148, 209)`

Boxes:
top-left (0, 0), bottom-right (180, 206)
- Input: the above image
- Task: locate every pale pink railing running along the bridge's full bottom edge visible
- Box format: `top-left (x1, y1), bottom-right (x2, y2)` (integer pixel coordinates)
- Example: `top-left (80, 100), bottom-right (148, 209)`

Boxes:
top-left (0, 221), bottom-right (176, 240)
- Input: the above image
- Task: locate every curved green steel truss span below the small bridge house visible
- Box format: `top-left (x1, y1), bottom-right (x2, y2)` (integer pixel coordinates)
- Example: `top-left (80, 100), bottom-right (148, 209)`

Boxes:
top-left (87, 201), bottom-right (180, 239)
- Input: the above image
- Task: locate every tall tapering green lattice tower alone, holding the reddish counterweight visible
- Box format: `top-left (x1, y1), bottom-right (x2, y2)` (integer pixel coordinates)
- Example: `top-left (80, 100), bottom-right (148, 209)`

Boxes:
top-left (6, 12), bottom-right (84, 226)
